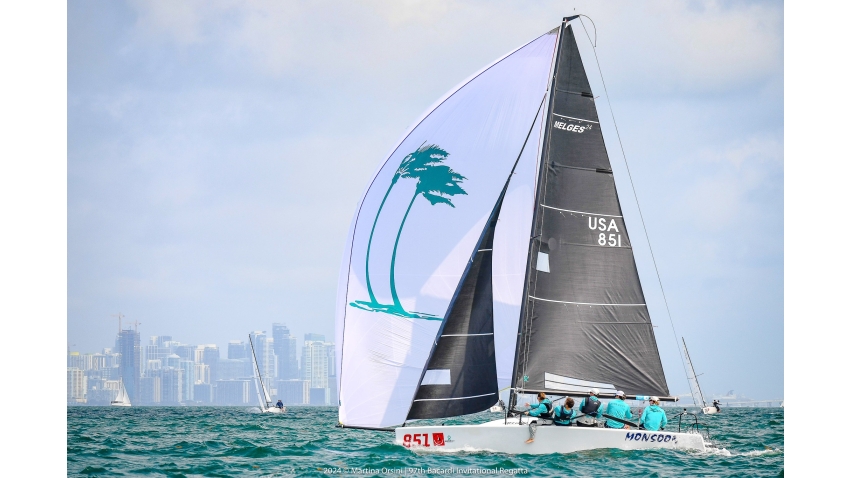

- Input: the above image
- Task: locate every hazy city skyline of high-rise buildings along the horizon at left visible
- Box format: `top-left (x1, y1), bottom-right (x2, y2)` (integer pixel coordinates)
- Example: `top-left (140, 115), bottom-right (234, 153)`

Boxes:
top-left (67, 322), bottom-right (337, 406)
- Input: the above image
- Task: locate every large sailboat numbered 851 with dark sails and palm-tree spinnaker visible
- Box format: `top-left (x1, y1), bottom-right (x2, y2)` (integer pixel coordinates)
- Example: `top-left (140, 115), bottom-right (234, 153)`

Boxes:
top-left (336, 16), bottom-right (706, 454)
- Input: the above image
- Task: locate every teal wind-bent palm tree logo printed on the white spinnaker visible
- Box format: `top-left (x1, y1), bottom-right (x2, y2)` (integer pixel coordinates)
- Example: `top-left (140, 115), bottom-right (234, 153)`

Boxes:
top-left (350, 143), bottom-right (466, 320)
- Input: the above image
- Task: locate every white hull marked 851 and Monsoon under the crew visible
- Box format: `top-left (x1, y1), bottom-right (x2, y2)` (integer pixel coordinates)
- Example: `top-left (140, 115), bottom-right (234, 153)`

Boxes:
top-left (395, 418), bottom-right (706, 455)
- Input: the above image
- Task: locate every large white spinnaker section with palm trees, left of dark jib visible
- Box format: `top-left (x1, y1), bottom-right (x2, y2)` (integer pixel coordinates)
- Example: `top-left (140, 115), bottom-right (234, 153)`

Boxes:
top-left (336, 33), bottom-right (556, 427)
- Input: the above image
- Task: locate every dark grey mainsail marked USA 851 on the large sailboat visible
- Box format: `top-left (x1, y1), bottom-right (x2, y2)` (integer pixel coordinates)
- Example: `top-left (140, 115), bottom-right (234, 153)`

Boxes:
top-left (513, 19), bottom-right (669, 396)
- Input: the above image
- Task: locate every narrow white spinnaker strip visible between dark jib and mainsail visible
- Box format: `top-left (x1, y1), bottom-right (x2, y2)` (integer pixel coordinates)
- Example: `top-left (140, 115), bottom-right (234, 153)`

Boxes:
top-left (493, 106), bottom-right (548, 390)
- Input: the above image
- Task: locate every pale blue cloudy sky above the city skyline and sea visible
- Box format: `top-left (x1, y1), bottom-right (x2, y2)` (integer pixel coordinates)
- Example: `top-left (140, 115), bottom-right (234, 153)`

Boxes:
top-left (67, 0), bottom-right (784, 398)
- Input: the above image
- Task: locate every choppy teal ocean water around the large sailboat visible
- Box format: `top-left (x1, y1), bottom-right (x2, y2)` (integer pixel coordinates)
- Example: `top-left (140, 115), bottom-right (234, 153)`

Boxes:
top-left (68, 407), bottom-right (785, 477)
